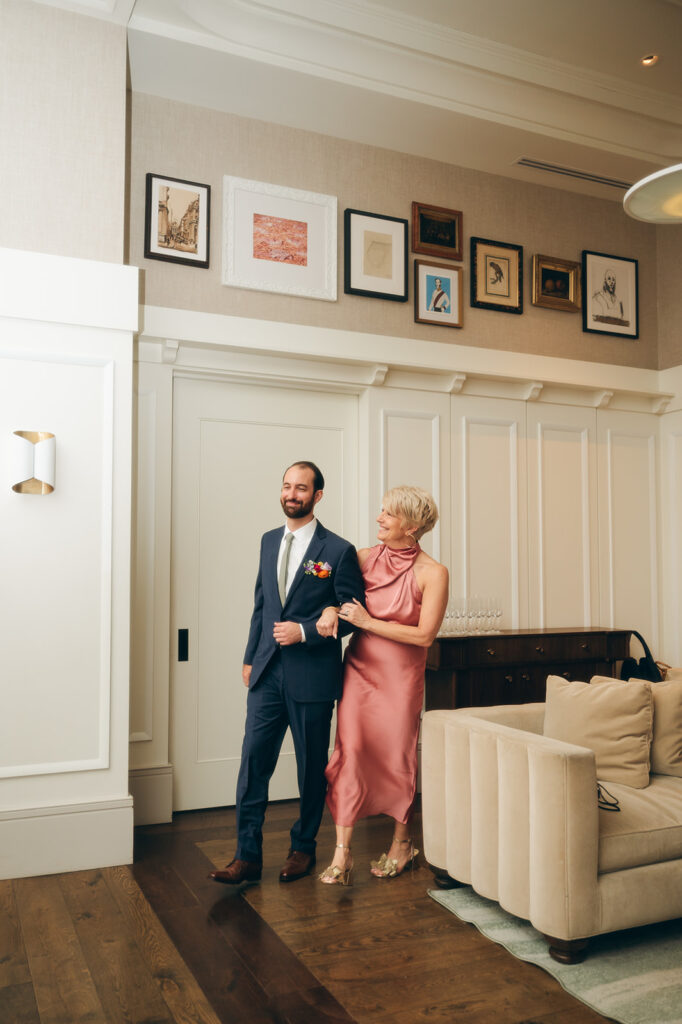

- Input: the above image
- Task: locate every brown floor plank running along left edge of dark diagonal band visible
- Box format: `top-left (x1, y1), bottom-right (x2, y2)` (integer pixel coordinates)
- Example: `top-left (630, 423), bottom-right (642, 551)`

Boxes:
top-left (102, 867), bottom-right (221, 1024)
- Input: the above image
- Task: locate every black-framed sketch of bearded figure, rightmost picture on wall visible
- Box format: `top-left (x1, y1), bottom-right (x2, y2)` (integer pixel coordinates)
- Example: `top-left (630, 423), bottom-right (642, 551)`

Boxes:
top-left (583, 249), bottom-right (639, 338)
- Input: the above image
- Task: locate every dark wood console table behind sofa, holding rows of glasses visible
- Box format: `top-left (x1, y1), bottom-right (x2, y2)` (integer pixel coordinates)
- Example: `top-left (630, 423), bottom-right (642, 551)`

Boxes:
top-left (425, 629), bottom-right (631, 711)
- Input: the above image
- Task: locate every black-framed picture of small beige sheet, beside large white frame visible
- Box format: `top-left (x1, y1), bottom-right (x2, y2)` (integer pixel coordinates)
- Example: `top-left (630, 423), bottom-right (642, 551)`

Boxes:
top-left (343, 210), bottom-right (408, 302)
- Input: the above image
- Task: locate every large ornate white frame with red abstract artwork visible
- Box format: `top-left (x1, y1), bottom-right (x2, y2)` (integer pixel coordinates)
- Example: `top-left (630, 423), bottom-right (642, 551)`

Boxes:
top-left (222, 175), bottom-right (337, 302)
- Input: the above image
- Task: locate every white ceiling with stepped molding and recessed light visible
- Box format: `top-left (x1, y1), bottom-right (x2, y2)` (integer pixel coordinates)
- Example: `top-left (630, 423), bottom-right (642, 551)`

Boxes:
top-left (31, 0), bottom-right (682, 202)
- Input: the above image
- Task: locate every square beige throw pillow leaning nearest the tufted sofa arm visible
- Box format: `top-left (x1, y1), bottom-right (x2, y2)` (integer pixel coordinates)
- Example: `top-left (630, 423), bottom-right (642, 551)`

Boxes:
top-left (544, 676), bottom-right (653, 790)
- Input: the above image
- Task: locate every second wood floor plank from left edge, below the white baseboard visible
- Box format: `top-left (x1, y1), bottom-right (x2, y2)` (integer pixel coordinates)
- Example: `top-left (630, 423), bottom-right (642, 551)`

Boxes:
top-left (14, 876), bottom-right (108, 1024)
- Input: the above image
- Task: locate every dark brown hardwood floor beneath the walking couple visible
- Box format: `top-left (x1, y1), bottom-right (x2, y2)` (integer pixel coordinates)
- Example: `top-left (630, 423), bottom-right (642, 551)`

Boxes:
top-left (0, 803), bottom-right (605, 1024)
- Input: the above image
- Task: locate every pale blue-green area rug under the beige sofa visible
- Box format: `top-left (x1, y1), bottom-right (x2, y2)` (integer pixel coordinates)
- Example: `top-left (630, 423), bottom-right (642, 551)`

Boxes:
top-left (429, 886), bottom-right (682, 1024)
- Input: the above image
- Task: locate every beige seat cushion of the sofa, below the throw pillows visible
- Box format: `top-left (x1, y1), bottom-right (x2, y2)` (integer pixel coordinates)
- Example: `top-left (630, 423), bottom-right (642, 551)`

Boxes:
top-left (599, 775), bottom-right (682, 873)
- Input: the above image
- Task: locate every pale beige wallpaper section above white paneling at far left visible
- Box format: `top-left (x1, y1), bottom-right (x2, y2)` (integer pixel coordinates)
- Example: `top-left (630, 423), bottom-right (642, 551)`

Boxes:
top-left (0, 0), bottom-right (126, 263)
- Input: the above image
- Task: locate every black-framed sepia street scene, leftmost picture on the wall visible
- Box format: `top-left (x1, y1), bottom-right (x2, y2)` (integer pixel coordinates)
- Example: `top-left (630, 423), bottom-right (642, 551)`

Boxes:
top-left (144, 174), bottom-right (211, 269)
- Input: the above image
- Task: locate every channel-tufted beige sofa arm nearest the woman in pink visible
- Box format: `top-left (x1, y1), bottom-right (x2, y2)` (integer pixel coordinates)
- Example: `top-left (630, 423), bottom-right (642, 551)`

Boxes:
top-left (422, 703), bottom-right (602, 941)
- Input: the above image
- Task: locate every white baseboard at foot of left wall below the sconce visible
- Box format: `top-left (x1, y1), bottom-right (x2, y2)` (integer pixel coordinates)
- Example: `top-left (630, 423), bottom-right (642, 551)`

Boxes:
top-left (0, 797), bottom-right (133, 879)
